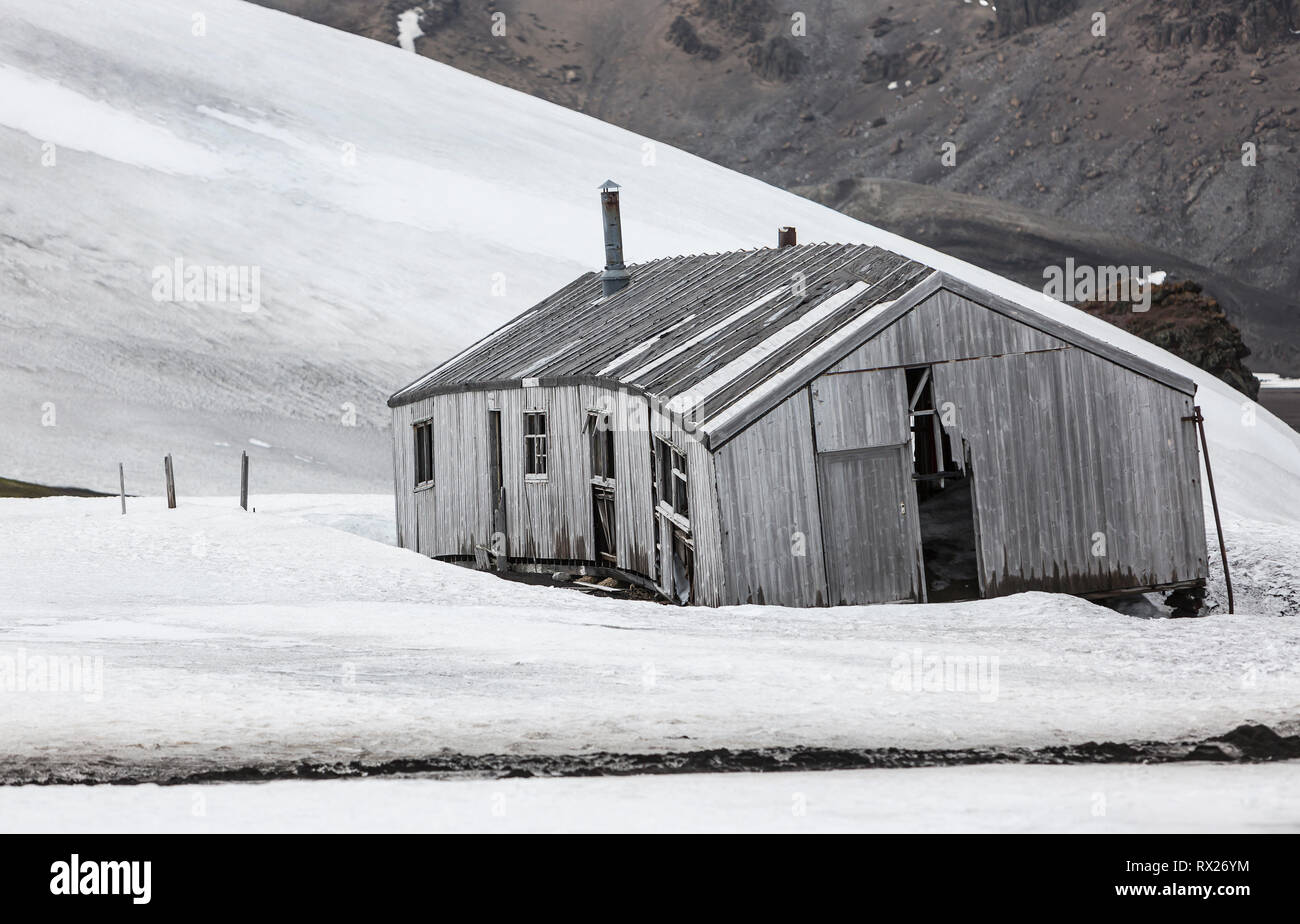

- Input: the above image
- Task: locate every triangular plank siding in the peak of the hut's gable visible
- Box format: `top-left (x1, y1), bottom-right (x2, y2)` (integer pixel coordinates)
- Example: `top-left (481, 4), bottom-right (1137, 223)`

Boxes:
top-left (831, 290), bottom-right (1069, 372)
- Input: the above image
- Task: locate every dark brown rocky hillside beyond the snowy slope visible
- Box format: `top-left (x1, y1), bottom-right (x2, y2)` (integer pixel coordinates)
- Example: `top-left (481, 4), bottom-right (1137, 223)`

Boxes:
top-left (250, 0), bottom-right (1300, 374)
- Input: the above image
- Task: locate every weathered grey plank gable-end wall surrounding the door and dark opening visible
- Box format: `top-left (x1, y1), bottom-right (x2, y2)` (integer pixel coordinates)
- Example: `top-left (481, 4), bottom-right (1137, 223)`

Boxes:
top-left (715, 291), bottom-right (1206, 606)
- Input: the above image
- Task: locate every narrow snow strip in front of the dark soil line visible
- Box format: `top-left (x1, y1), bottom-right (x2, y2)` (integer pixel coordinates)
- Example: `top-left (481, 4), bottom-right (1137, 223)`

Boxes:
top-left (0, 764), bottom-right (1300, 834)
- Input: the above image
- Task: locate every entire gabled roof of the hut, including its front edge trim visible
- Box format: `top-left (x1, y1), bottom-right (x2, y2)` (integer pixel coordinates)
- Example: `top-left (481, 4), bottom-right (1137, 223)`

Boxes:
top-left (389, 244), bottom-right (1195, 444)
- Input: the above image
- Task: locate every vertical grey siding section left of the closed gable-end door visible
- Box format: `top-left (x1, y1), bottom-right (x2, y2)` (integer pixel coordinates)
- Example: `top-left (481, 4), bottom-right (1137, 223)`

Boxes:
top-left (714, 389), bottom-right (827, 607)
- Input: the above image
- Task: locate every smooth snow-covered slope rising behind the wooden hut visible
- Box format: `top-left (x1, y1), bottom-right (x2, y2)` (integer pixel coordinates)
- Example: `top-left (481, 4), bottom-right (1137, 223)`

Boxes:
top-left (0, 0), bottom-right (1300, 522)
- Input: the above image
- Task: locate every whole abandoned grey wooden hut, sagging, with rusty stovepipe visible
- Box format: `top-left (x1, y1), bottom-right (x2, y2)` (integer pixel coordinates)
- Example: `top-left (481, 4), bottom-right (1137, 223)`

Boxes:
top-left (389, 183), bottom-right (1206, 606)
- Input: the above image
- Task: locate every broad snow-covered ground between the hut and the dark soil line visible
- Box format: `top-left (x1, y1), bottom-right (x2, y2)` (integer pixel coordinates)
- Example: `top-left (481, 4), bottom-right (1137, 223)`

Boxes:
top-left (0, 496), bottom-right (1300, 773)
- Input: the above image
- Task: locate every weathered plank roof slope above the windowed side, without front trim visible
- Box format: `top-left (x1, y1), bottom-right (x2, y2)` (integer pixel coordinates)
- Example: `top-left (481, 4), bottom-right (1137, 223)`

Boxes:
top-left (389, 244), bottom-right (932, 407)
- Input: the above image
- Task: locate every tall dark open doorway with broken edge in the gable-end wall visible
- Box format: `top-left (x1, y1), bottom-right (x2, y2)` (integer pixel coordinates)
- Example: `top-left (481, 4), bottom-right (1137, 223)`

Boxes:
top-left (906, 366), bottom-right (980, 603)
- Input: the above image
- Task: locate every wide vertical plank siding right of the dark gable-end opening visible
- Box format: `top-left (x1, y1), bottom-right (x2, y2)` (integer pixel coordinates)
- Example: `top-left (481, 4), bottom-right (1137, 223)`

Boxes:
top-left (933, 348), bottom-right (1206, 597)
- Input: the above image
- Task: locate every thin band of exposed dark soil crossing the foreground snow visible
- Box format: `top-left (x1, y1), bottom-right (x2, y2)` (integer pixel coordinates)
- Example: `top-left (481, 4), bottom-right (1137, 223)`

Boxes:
top-left (0, 725), bottom-right (1300, 785)
